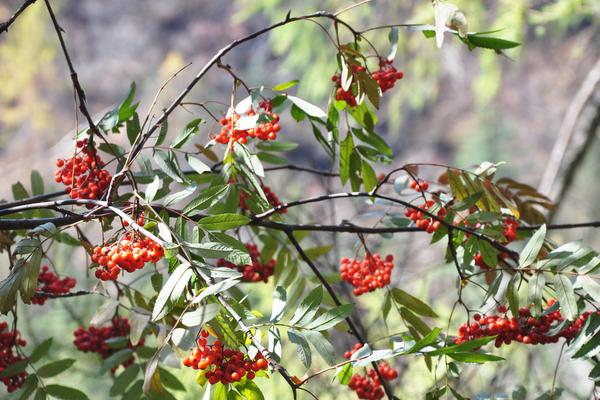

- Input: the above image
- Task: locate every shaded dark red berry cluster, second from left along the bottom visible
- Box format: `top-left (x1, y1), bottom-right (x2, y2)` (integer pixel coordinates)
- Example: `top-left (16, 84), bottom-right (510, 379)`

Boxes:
top-left (73, 316), bottom-right (144, 373)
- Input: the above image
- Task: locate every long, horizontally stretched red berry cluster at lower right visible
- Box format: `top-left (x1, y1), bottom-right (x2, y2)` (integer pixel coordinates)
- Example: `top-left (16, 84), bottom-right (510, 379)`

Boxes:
top-left (454, 299), bottom-right (600, 347)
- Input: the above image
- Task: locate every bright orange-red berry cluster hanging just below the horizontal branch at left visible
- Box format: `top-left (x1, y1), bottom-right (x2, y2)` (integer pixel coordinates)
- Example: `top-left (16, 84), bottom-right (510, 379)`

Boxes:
top-left (92, 233), bottom-right (165, 281)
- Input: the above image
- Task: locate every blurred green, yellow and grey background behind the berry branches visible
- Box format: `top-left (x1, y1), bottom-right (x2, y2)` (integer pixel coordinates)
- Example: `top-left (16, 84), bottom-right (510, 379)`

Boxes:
top-left (0, 0), bottom-right (600, 399)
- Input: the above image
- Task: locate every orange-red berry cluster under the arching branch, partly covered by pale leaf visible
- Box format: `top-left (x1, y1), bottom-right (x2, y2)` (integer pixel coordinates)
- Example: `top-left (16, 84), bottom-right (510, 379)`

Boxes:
top-left (214, 100), bottom-right (281, 144)
